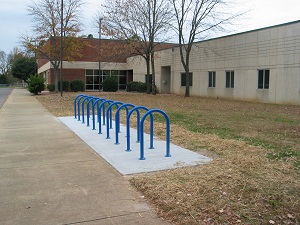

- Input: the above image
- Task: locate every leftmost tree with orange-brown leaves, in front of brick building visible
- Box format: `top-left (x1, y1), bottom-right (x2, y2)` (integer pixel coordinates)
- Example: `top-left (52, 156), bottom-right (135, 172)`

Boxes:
top-left (22, 0), bottom-right (83, 91)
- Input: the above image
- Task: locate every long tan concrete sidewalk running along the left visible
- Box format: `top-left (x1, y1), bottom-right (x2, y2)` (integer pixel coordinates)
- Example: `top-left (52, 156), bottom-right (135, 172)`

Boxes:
top-left (0, 89), bottom-right (168, 225)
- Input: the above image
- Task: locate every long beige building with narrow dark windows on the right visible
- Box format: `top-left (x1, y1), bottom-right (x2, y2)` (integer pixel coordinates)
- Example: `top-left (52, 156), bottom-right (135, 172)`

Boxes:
top-left (127, 21), bottom-right (300, 105)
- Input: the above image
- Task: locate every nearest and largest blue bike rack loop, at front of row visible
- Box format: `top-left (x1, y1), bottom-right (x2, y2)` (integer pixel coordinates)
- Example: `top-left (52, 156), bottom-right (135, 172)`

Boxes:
top-left (140, 109), bottom-right (171, 160)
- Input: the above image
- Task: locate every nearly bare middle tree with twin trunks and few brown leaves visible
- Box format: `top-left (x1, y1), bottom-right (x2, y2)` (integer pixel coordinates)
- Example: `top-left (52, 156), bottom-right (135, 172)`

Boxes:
top-left (103, 0), bottom-right (172, 94)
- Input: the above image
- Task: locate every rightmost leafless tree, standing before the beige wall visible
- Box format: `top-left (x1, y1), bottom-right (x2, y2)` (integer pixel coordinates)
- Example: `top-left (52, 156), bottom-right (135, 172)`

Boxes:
top-left (169, 0), bottom-right (240, 97)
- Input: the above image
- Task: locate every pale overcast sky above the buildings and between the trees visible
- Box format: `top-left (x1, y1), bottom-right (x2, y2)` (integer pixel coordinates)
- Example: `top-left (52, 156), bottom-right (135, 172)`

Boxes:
top-left (0, 0), bottom-right (300, 53)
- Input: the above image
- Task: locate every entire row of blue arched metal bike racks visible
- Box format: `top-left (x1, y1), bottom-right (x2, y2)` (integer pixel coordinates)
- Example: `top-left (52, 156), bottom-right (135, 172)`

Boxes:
top-left (74, 94), bottom-right (171, 160)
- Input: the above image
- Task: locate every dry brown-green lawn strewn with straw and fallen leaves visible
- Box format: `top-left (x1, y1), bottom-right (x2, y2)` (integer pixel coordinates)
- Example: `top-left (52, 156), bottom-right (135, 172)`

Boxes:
top-left (36, 92), bottom-right (300, 224)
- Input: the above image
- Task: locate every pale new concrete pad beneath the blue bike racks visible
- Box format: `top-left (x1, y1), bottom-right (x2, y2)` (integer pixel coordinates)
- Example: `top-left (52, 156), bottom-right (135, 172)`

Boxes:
top-left (59, 117), bottom-right (211, 175)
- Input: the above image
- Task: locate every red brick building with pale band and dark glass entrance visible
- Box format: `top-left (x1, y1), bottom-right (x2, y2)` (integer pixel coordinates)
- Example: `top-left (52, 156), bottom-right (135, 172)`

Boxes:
top-left (38, 38), bottom-right (175, 91)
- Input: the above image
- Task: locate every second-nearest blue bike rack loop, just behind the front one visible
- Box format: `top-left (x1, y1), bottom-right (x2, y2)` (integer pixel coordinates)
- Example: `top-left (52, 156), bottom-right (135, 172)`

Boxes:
top-left (126, 106), bottom-right (153, 152)
